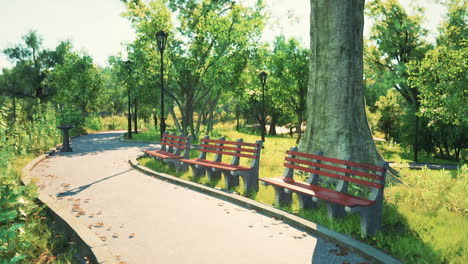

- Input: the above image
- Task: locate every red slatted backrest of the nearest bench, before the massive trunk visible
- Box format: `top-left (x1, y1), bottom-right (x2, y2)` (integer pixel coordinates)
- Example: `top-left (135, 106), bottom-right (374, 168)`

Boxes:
top-left (283, 147), bottom-right (387, 198)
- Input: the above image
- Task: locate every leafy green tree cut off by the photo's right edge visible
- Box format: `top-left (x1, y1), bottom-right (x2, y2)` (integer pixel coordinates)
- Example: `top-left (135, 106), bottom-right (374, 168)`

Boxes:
top-left (408, 1), bottom-right (468, 160)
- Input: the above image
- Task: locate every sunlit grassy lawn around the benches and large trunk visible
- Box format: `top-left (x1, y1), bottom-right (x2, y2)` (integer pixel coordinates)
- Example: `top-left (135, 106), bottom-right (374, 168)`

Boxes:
top-left (139, 124), bottom-right (468, 264)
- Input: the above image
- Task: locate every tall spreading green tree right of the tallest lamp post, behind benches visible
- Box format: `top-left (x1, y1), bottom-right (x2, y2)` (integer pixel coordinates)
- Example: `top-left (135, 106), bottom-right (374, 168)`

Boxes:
top-left (169, 0), bottom-right (263, 136)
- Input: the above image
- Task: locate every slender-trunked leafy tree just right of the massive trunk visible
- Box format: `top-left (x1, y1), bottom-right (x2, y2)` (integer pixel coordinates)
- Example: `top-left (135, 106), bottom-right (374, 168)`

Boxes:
top-left (367, 0), bottom-right (431, 162)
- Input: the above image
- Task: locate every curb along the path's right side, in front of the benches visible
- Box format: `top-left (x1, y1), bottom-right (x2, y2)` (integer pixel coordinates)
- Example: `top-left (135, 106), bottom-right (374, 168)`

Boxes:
top-left (128, 158), bottom-right (403, 264)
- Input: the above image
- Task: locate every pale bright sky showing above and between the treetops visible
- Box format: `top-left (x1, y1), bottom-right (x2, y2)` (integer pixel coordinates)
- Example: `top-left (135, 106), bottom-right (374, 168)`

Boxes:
top-left (0, 0), bottom-right (446, 69)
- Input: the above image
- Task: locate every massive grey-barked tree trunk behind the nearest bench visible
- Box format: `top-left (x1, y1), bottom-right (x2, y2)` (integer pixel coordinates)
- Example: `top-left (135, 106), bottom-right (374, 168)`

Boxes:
top-left (300, 0), bottom-right (382, 164)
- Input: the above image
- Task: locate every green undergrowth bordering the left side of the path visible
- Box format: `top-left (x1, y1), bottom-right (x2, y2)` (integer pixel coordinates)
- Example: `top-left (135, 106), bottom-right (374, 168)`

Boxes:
top-left (0, 104), bottom-right (76, 264)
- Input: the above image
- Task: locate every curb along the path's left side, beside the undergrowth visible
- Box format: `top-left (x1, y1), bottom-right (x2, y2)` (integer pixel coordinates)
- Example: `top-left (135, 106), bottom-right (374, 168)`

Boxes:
top-left (21, 147), bottom-right (117, 264)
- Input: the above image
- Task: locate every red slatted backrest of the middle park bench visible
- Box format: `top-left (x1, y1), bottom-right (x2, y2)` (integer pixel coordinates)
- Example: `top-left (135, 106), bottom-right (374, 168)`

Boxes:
top-left (199, 136), bottom-right (263, 168)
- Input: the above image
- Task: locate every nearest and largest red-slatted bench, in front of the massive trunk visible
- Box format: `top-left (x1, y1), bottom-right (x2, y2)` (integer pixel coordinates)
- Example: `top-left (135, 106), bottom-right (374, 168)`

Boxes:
top-left (260, 147), bottom-right (388, 236)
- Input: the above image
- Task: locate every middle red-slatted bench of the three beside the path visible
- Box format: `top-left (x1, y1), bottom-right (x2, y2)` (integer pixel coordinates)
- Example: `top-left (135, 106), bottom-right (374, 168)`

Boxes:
top-left (180, 136), bottom-right (263, 193)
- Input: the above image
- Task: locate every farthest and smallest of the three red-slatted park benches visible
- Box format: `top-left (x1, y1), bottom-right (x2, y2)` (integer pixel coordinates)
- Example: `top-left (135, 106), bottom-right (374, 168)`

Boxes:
top-left (144, 132), bottom-right (192, 171)
